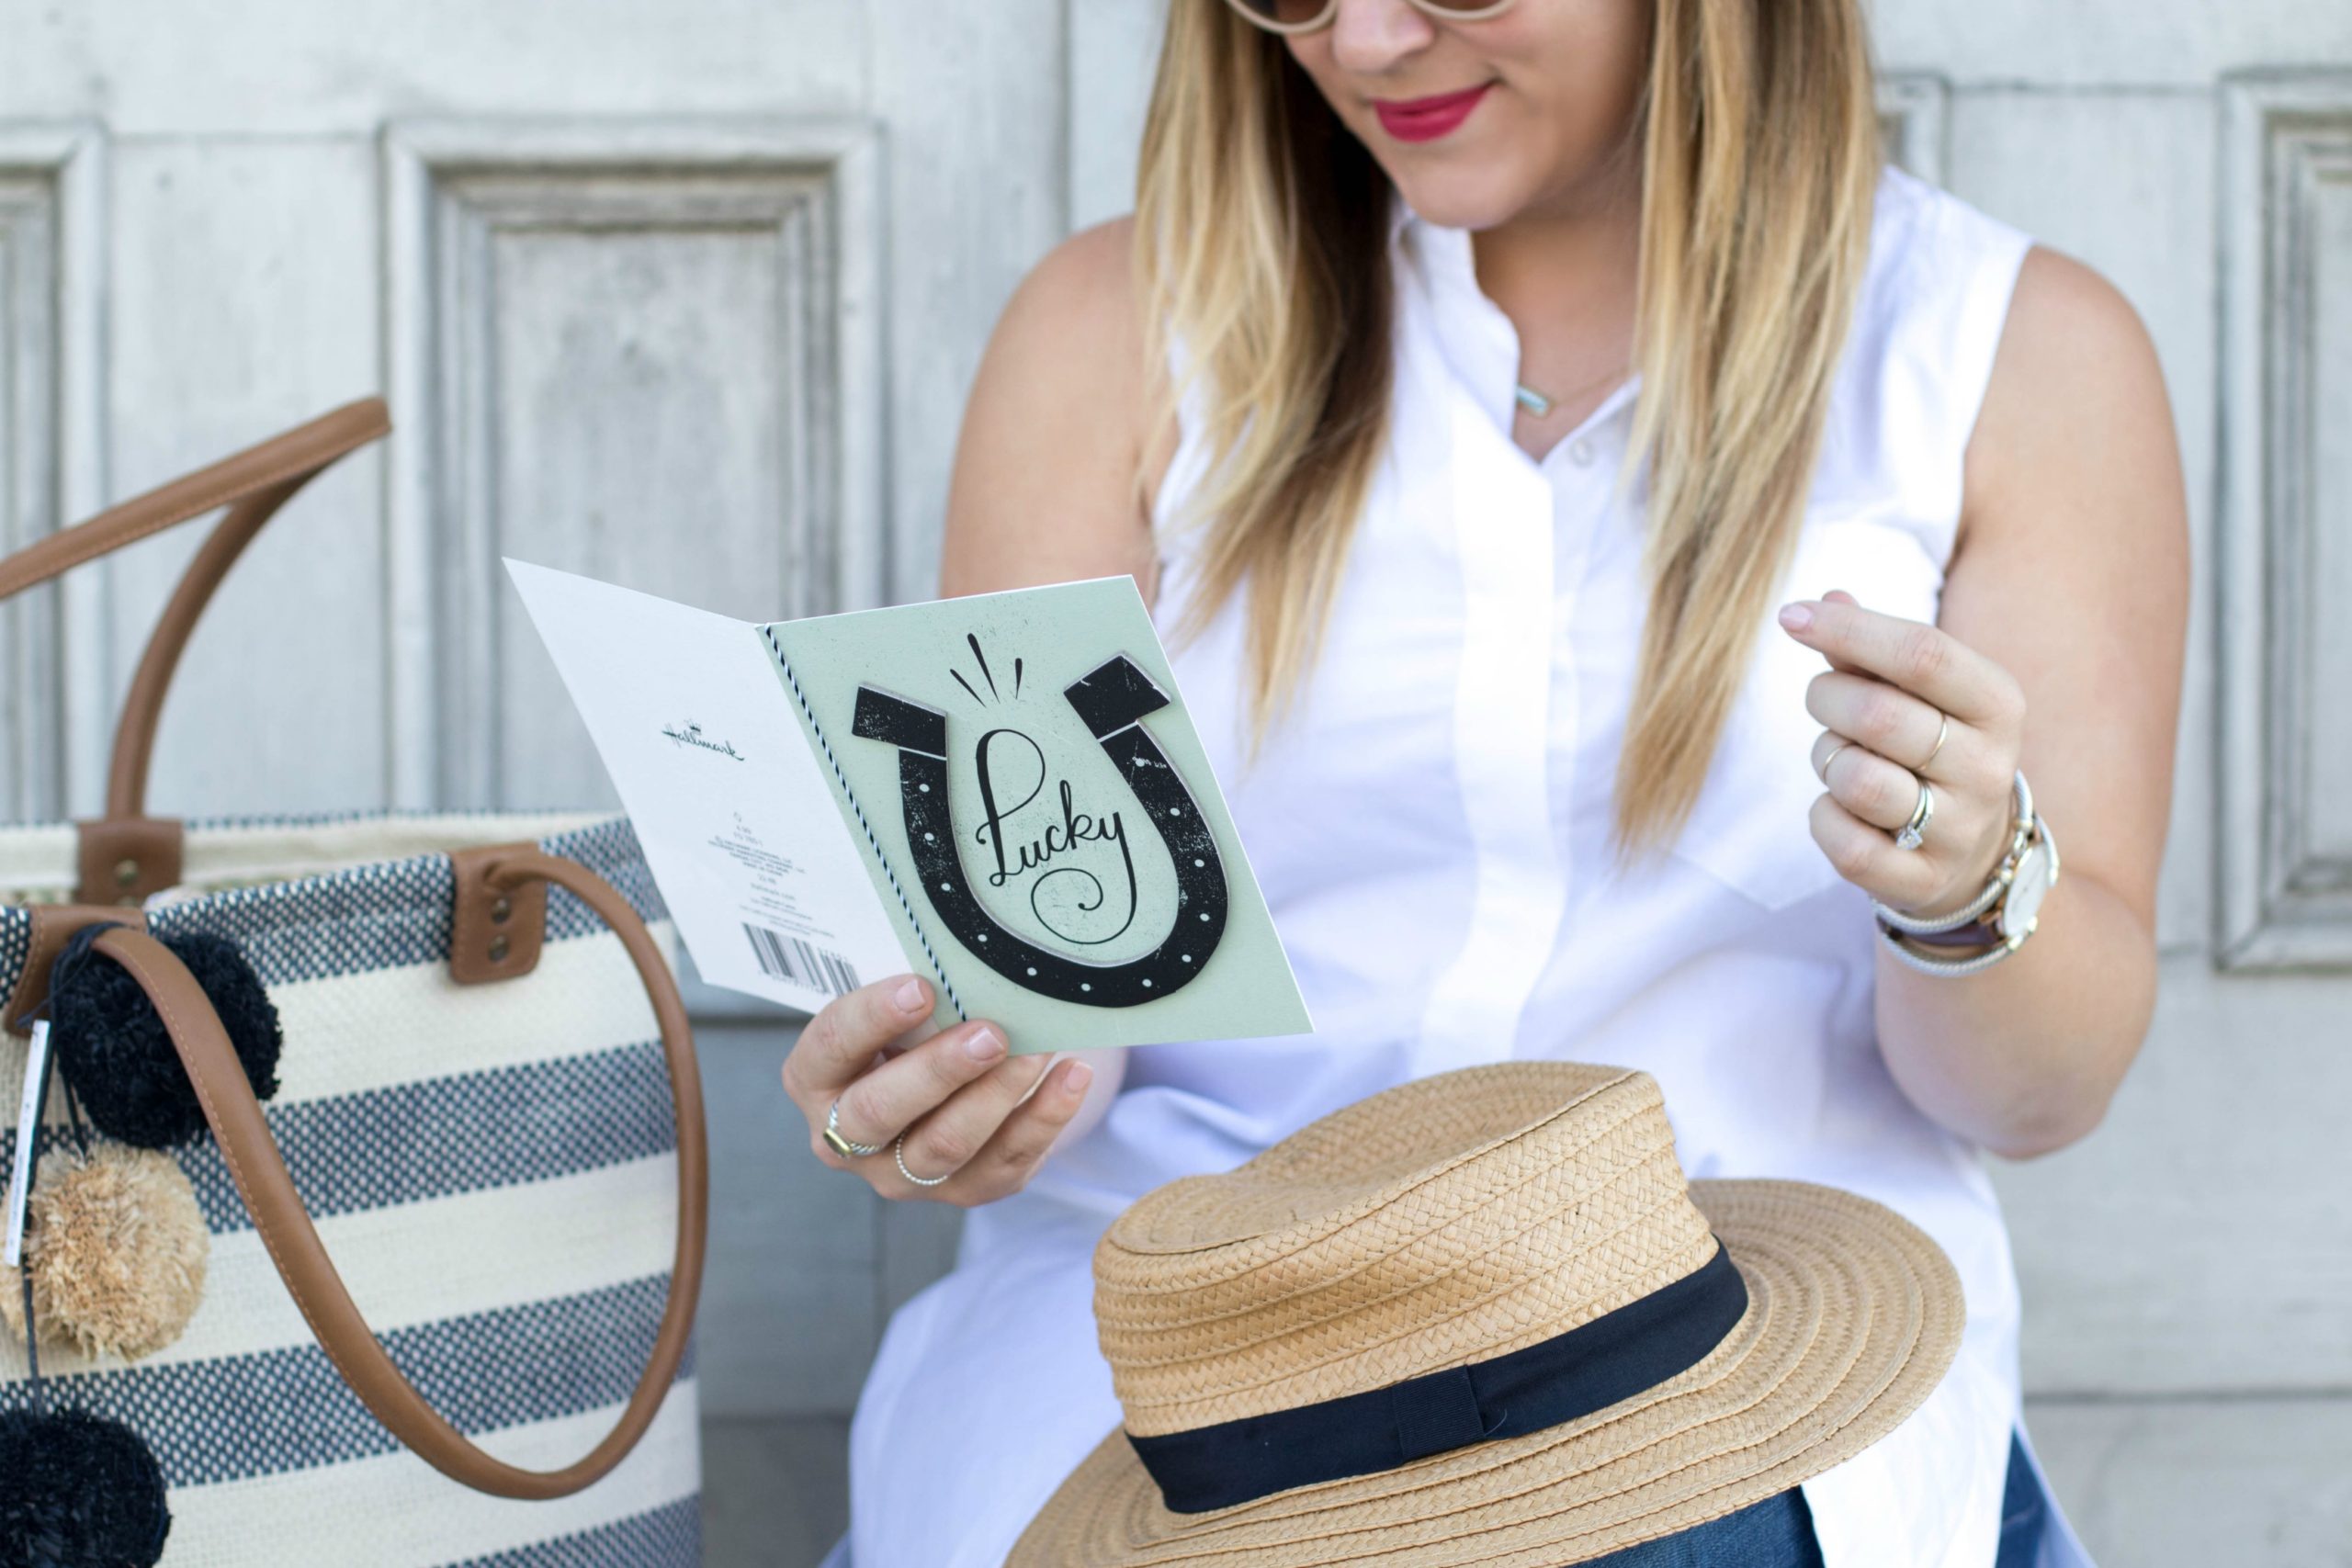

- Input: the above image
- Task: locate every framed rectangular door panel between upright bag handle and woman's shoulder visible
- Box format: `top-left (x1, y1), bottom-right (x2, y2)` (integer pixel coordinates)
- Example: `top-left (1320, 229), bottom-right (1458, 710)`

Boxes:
top-left (383, 120), bottom-right (882, 807)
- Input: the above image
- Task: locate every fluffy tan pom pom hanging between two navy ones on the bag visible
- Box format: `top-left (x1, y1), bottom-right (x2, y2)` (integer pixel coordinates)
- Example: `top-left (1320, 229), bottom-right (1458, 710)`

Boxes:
top-left (0, 1140), bottom-right (211, 1361)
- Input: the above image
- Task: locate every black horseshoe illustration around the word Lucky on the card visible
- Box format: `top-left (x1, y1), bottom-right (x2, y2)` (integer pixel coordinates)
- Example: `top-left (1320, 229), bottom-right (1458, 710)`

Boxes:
top-left (849, 653), bottom-right (1226, 1006)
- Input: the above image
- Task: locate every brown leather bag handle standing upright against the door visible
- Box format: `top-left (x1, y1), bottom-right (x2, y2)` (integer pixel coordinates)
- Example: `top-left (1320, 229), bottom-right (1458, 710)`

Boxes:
top-left (0, 398), bottom-right (393, 820)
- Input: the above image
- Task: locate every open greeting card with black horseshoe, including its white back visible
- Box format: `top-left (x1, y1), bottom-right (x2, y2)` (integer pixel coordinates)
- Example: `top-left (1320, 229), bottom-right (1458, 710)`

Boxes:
top-left (505, 559), bottom-right (1312, 1054)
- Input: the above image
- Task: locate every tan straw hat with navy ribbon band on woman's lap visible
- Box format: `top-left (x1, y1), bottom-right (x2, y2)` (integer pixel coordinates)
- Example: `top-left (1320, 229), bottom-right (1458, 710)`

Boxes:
top-left (1007, 1063), bottom-right (1964, 1568)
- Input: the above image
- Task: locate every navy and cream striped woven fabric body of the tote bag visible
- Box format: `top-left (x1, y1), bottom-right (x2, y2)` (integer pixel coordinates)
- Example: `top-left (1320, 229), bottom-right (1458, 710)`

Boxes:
top-left (0, 813), bottom-right (701, 1568)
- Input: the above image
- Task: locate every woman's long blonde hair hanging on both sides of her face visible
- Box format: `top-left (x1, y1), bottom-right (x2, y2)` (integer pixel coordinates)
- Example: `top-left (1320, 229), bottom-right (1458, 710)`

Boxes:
top-left (1134, 0), bottom-right (1884, 863)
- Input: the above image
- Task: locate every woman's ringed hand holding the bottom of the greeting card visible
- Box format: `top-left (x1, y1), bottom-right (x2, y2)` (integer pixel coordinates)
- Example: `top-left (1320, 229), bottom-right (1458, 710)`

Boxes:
top-left (783, 974), bottom-right (1093, 1208)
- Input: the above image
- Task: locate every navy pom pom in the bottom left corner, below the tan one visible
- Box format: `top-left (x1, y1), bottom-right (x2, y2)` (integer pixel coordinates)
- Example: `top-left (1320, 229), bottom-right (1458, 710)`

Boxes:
top-left (0, 1411), bottom-right (172, 1568)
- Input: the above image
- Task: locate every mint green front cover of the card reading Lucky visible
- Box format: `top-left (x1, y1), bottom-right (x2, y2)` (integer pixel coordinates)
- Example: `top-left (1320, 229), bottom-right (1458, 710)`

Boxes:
top-left (760, 576), bottom-right (1312, 1054)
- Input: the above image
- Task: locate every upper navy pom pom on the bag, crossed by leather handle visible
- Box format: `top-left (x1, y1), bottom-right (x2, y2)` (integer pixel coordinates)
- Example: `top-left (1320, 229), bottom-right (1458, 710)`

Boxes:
top-left (50, 924), bottom-right (282, 1149)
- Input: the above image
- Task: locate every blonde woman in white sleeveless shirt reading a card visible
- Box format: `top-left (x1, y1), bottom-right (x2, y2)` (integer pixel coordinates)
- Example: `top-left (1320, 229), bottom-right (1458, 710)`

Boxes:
top-left (783, 0), bottom-right (2188, 1568)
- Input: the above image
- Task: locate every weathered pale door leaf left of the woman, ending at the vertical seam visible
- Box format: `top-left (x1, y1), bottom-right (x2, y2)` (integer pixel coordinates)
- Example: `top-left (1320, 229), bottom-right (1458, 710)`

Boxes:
top-left (0, 0), bottom-right (1070, 1563)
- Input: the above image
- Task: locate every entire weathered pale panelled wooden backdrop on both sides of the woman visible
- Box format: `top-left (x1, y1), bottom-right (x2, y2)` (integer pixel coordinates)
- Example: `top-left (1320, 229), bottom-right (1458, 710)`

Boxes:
top-left (0, 0), bottom-right (2352, 1565)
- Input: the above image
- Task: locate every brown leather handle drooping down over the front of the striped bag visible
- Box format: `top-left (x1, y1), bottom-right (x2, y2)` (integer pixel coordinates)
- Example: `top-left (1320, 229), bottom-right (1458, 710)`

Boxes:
top-left (94, 849), bottom-right (710, 1500)
